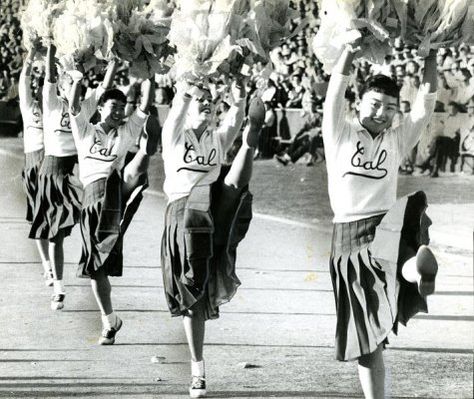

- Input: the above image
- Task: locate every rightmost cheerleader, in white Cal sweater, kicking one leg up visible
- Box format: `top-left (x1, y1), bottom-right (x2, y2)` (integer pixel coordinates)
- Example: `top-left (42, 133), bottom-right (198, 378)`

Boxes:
top-left (322, 43), bottom-right (438, 399)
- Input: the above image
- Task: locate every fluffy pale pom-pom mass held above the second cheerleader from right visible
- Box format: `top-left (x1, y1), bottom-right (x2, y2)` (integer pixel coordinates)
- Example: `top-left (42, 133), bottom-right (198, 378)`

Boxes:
top-left (169, 0), bottom-right (298, 80)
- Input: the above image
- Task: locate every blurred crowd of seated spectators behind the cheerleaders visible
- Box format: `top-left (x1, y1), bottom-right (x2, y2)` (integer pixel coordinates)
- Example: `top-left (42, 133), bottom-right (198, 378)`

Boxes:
top-left (0, 0), bottom-right (474, 177)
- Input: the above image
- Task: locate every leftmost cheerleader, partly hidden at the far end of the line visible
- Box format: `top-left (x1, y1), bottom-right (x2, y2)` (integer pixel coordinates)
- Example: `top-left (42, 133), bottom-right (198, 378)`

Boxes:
top-left (18, 47), bottom-right (53, 287)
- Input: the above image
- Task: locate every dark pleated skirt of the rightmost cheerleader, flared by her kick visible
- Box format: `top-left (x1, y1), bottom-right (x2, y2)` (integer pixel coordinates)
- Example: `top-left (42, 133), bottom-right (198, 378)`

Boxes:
top-left (330, 191), bottom-right (431, 361)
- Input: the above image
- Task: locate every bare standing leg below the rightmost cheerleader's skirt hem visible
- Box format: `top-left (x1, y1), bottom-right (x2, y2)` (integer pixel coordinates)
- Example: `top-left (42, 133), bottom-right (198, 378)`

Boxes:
top-left (358, 345), bottom-right (385, 399)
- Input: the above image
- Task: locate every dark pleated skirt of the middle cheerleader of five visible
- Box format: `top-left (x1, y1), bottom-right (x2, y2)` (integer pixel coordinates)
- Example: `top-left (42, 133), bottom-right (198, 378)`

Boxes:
top-left (77, 172), bottom-right (147, 277)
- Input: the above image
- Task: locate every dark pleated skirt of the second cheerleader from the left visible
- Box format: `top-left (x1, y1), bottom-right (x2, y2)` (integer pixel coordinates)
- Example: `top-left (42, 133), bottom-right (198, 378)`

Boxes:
top-left (29, 155), bottom-right (82, 239)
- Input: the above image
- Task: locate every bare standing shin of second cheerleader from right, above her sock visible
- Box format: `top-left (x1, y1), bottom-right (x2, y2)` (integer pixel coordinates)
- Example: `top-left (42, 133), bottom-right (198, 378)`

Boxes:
top-left (183, 300), bottom-right (206, 362)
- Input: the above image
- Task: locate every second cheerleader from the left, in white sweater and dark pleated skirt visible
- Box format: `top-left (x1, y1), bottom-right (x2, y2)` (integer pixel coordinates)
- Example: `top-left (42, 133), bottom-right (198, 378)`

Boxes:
top-left (30, 44), bottom-right (115, 310)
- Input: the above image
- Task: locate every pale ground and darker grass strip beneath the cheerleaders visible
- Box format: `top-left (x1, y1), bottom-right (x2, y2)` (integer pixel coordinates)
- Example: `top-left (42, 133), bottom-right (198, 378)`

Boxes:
top-left (0, 139), bottom-right (474, 399)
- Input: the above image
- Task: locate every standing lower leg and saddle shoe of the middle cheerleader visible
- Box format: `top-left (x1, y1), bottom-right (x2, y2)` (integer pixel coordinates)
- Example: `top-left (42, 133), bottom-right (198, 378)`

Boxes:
top-left (91, 268), bottom-right (122, 345)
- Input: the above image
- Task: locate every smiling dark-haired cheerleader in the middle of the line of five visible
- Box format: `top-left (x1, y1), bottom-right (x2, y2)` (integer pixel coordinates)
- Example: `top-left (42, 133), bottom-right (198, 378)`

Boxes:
top-left (70, 65), bottom-right (153, 345)
